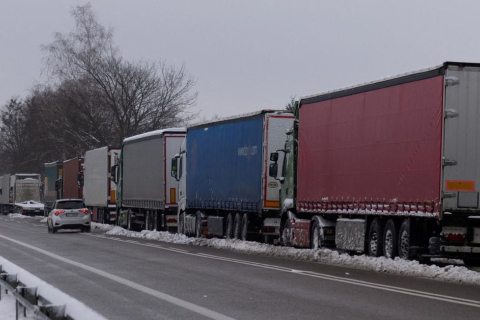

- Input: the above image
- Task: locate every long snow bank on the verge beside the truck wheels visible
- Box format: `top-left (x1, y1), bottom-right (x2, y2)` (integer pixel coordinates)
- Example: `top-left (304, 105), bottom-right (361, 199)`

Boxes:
top-left (92, 223), bottom-right (480, 285)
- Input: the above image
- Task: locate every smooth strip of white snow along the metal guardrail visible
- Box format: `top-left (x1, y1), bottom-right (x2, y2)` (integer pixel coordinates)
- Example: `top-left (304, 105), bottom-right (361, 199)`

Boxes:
top-left (0, 256), bottom-right (105, 320)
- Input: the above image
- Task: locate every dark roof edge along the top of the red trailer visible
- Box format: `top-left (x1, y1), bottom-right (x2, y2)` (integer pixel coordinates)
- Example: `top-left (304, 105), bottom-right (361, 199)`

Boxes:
top-left (300, 61), bottom-right (480, 106)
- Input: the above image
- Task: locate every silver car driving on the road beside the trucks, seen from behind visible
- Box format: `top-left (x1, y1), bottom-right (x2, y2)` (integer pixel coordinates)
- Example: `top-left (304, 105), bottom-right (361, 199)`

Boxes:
top-left (47, 199), bottom-right (91, 233)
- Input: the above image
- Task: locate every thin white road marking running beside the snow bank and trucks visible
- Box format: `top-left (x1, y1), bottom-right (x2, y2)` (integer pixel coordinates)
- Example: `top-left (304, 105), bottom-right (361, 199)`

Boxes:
top-left (84, 235), bottom-right (480, 308)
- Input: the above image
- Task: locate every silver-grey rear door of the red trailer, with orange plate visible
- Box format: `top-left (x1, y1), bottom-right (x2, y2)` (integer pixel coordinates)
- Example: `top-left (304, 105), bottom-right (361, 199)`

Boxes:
top-left (442, 65), bottom-right (480, 211)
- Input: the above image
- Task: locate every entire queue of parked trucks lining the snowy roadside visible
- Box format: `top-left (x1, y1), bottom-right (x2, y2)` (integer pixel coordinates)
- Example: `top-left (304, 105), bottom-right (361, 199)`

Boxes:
top-left (0, 62), bottom-right (480, 262)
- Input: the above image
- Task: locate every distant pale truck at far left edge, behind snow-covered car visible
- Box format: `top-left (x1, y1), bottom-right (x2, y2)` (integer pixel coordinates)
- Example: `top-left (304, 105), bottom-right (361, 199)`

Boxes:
top-left (0, 173), bottom-right (42, 214)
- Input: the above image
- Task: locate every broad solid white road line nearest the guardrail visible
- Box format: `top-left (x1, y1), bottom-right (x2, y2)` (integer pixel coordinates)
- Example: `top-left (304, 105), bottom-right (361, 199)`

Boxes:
top-left (0, 235), bottom-right (233, 320)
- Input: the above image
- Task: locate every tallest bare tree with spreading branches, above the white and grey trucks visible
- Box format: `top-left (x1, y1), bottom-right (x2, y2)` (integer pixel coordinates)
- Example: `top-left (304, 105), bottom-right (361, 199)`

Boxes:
top-left (43, 4), bottom-right (197, 144)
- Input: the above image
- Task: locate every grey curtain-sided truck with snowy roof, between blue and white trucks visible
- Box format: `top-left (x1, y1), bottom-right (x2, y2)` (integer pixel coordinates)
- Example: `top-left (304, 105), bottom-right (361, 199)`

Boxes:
top-left (114, 128), bottom-right (185, 230)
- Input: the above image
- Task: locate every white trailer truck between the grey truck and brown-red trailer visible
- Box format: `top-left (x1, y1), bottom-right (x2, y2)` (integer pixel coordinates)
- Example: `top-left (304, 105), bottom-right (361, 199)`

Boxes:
top-left (83, 147), bottom-right (120, 223)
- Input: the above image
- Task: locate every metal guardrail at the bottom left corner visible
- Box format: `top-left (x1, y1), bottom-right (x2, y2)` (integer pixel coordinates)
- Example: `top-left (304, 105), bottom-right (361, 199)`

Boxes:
top-left (0, 265), bottom-right (67, 320)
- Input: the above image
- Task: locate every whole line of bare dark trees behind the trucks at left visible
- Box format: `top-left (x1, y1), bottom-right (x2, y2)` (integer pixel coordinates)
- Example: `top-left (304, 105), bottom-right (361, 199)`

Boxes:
top-left (0, 4), bottom-right (197, 173)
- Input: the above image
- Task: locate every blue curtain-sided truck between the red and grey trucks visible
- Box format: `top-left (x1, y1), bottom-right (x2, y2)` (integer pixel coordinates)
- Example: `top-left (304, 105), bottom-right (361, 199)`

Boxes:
top-left (172, 110), bottom-right (294, 242)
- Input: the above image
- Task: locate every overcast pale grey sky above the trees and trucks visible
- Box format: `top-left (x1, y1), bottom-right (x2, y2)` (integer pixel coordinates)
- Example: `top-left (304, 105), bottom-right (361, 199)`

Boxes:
top-left (0, 0), bottom-right (480, 118)
